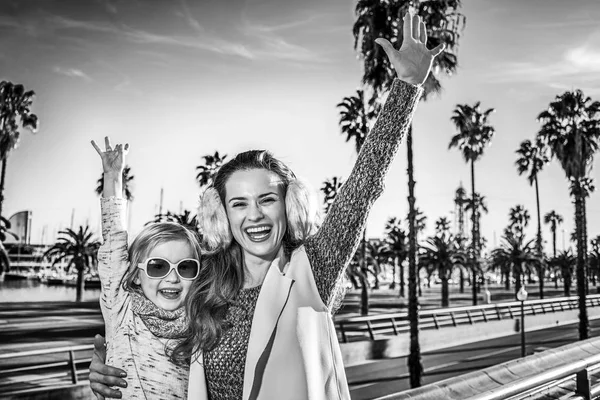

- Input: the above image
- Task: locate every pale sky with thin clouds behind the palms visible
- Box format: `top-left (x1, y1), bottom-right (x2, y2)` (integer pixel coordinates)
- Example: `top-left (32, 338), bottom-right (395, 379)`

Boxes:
top-left (0, 0), bottom-right (600, 255)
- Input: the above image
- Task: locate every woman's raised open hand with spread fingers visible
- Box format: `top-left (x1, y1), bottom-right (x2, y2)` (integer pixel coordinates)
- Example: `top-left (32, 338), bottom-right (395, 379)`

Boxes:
top-left (375, 13), bottom-right (445, 85)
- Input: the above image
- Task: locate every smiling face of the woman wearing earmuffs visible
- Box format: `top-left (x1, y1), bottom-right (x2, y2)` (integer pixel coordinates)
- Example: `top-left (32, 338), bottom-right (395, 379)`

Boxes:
top-left (225, 169), bottom-right (287, 261)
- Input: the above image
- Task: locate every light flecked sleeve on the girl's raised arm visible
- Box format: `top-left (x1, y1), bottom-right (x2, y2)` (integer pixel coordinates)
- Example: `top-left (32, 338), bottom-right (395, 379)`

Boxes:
top-left (98, 197), bottom-right (129, 311)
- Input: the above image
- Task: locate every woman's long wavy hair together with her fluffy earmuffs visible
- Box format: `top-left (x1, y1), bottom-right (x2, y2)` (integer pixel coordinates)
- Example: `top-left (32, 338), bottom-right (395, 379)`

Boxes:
top-left (173, 150), bottom-right (319, 360)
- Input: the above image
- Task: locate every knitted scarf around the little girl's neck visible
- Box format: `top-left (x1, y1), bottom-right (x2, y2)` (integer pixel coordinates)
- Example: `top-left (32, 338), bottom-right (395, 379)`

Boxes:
top-left (131, 290), bottom-right (188, 339)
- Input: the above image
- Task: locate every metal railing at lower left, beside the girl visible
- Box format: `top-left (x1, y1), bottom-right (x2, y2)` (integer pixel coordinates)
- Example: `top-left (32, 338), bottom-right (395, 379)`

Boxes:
top-left (0, 345), bottom-right (94, 395)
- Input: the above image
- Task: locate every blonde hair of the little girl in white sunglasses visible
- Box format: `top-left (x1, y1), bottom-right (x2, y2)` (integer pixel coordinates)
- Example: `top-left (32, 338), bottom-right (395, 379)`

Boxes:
top-left (122, 222), bottom-right (202, 291)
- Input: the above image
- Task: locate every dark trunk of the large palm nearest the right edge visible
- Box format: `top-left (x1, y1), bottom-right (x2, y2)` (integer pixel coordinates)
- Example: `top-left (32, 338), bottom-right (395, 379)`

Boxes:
top-left (575, 188), bottom-right (590, 340)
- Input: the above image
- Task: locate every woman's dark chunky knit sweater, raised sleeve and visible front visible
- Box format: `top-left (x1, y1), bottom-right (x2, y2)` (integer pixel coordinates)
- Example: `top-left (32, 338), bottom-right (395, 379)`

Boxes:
top-left (204, 80), bottom-right (422, 400)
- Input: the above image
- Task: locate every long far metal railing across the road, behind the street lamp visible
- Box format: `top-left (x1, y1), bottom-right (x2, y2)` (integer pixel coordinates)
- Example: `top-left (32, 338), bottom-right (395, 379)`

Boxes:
top-left (334, 294), bottom-right (600, 343)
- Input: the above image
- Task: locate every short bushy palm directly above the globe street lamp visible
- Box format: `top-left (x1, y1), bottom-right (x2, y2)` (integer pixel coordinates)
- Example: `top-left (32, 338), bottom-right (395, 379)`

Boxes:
top-left (491, 231), bottom-right (539, 294)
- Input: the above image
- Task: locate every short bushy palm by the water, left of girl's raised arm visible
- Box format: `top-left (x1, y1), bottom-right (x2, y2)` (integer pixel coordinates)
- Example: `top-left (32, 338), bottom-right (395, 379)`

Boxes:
top-left (44, 226), bottom-right (99, 302)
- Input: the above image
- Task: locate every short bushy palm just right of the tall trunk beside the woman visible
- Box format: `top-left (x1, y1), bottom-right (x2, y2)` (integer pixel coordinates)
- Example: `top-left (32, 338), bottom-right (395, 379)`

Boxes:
top-left (419, 232), bottom-right (457, 307)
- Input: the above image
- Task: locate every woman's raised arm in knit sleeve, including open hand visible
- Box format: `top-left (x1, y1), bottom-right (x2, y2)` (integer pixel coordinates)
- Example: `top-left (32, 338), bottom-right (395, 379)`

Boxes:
top-left (305, 14), bottom-right (443, 308)
